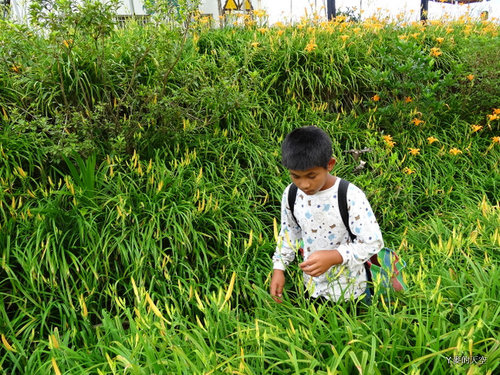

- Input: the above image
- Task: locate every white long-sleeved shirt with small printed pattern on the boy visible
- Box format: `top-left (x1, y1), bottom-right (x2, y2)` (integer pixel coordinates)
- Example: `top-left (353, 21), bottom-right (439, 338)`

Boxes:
top-left (273, 177), bottom-right (384, 301)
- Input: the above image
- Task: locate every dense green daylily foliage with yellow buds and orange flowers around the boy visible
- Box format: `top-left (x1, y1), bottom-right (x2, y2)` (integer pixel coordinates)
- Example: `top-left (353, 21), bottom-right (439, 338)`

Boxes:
top-left (0, 0), bottom-right (500, 374)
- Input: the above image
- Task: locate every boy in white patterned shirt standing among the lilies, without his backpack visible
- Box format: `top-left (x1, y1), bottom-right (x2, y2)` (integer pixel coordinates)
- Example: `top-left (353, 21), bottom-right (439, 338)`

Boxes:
top-left (270, 126), bottom-right (384, 302)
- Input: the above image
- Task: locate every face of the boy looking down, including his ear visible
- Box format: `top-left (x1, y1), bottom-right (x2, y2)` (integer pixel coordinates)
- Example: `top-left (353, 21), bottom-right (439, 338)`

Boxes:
top-left (289, 158), bottom-right (335, 195)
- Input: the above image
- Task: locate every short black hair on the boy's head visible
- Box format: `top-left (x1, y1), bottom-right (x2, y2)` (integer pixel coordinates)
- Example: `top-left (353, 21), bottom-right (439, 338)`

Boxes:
top-left (281, 126), bottom-right (332, 171)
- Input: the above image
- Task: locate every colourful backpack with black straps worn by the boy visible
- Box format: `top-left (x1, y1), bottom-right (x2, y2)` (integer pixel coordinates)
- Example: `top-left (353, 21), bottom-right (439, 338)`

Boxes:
top-left (288, 179), bottom-right (407, 295)
